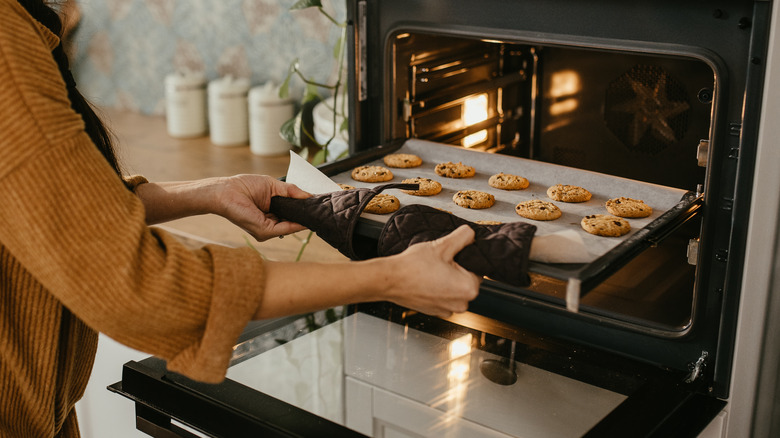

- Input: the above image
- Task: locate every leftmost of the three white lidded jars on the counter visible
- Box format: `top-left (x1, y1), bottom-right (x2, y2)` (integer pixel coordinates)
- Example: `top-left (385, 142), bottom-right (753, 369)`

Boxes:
top-left (165, 72), bottom-right (208, 138)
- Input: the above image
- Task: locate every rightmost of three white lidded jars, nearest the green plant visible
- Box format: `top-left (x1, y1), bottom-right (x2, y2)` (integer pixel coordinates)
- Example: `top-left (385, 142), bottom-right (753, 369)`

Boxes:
top-left (249, 82), bottom-right (295, 156)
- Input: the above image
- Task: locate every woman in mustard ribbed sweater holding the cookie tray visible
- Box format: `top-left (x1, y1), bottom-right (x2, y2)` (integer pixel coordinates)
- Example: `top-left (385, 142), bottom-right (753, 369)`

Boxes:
top-left (0, 0), bottom-right (479, 437)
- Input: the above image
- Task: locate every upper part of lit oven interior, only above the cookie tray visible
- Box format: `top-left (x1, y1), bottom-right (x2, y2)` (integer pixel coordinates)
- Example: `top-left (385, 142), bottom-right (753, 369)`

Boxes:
top-left (387, 32), bottom-right (715, 190)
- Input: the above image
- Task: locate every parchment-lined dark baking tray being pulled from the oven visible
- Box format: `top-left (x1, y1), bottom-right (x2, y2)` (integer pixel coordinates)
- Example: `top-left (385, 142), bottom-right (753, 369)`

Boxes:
top-left (320, 139), bottom-right (703, 311)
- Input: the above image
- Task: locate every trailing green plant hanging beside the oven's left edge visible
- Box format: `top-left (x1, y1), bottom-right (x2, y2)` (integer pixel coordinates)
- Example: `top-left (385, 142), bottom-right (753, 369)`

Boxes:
top-left (279, 0), bottom-right (348, 165)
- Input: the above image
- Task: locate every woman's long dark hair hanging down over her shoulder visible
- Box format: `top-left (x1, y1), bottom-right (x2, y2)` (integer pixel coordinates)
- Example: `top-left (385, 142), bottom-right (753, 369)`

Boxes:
top-left (18, 0), bottom-right (122, 176)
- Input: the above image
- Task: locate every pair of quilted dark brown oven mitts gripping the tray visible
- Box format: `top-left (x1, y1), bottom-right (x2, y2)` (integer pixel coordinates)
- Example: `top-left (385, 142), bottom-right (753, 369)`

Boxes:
top-left (270, 184), bottom-right (536, 286)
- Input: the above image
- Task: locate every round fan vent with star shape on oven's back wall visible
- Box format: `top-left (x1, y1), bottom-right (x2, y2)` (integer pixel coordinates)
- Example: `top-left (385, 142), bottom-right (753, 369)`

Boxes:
top-left (605, 65), bottom-right (691, 154)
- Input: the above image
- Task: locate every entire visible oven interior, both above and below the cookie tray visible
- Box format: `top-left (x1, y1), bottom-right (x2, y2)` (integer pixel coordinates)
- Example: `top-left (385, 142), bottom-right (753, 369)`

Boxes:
top-left (385, 31), bottom-right (716, 337)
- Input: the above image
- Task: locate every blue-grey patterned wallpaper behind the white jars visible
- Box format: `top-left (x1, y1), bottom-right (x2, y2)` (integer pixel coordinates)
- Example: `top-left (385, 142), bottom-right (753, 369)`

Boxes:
top-left (71, 0), bottom-right (346, 115)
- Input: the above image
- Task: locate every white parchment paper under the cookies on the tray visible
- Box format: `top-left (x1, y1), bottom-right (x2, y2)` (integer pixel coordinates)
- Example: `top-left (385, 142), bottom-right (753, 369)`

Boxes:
top-left (287, 139), bottom-right (686, 263)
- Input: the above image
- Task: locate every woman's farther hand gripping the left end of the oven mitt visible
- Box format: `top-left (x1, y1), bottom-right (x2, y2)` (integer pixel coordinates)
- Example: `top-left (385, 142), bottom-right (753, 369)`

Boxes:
top-left (215, 175), bottom-right (311, 242)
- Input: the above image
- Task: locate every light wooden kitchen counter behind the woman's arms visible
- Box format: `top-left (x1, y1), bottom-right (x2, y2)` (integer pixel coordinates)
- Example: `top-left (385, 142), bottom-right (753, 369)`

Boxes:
top-left (100, 108), bottom-right (347, 262)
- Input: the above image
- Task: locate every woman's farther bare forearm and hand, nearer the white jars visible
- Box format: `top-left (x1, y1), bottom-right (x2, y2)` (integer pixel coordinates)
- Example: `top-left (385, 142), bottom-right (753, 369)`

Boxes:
top-left (135, 175), bottom-right (311, 241)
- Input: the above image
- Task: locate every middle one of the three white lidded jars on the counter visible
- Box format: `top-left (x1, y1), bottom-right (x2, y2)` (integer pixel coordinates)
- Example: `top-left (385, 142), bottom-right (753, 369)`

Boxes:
top-left (208, 76), bottom-right (249, 146)
